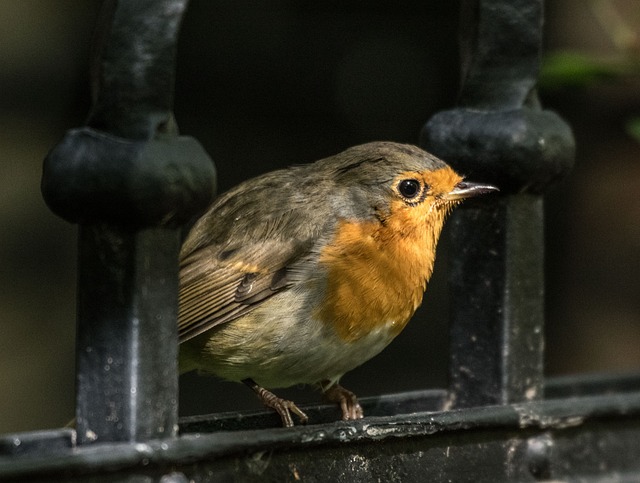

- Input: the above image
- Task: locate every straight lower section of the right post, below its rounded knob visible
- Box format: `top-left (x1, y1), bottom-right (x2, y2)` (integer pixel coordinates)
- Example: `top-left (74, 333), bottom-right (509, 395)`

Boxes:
top-left (450, 195), bottom-right (544, 407)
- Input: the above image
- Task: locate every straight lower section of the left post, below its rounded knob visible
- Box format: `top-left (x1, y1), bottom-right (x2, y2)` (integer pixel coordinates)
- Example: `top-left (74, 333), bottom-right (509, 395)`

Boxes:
top-left (76, 224), bottom-right (180, 442)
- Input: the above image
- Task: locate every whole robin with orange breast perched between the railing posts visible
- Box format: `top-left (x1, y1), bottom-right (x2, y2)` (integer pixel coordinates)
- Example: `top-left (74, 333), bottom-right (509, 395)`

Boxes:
top-left (178, 142), bottom-right (497, 427)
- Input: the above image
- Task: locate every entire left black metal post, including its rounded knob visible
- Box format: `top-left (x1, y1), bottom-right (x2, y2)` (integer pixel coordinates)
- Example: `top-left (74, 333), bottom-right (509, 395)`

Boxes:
top-left (42, 0), bottom-right (215, 444)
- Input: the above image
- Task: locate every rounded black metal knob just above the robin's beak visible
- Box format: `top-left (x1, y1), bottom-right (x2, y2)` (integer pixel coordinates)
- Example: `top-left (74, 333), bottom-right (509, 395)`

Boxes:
top-left (421, 107), bottom-right (575, 194)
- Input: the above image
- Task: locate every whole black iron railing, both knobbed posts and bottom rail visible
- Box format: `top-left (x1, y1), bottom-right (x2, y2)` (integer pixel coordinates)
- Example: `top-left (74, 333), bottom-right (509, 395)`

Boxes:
top-left (0, 0), bottom-right (640, 482)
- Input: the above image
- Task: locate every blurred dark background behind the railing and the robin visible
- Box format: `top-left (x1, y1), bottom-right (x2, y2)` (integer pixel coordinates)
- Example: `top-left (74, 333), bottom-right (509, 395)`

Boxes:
top-left (0, 0), bottom-right (640, 433)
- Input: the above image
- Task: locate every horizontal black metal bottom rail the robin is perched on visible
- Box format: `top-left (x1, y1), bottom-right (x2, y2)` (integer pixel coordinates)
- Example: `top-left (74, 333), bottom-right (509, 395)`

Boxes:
top-left (0, 376), bottom-right (640, 481)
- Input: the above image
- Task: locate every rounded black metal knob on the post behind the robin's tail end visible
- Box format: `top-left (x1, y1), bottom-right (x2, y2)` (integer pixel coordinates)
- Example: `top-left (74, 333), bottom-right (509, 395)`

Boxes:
top-left (42, 127), bottom-right (215, 227)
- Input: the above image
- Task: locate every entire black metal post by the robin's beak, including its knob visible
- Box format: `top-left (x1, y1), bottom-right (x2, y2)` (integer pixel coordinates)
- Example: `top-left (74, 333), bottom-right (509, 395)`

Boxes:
top-left (421, 0), bottom-right (574, 407)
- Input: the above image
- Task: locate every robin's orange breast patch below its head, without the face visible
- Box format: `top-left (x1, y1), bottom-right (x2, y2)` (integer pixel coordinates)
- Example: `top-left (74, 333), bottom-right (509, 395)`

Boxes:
top-left (317, 210), bottom-right (435, 341)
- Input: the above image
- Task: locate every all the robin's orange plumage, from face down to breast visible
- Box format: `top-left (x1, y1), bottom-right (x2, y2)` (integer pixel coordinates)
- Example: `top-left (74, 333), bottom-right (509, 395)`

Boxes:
top-left (316, 167), bottom-right (461, 341)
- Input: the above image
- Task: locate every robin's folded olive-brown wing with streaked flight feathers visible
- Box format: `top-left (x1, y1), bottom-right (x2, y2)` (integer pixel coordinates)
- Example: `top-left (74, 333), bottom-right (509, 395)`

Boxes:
top-left (178, 169), bottom-right (333, 342)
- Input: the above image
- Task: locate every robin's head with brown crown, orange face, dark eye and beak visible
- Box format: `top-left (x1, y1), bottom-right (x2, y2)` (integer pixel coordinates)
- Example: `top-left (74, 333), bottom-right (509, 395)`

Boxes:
top-left (316, 142), bottom-right (498, 238)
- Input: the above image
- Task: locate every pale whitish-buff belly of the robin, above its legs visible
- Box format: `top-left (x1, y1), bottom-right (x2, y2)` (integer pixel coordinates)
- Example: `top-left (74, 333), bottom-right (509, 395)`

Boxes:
top-left (189, 300), bottom-right (397, 388)
